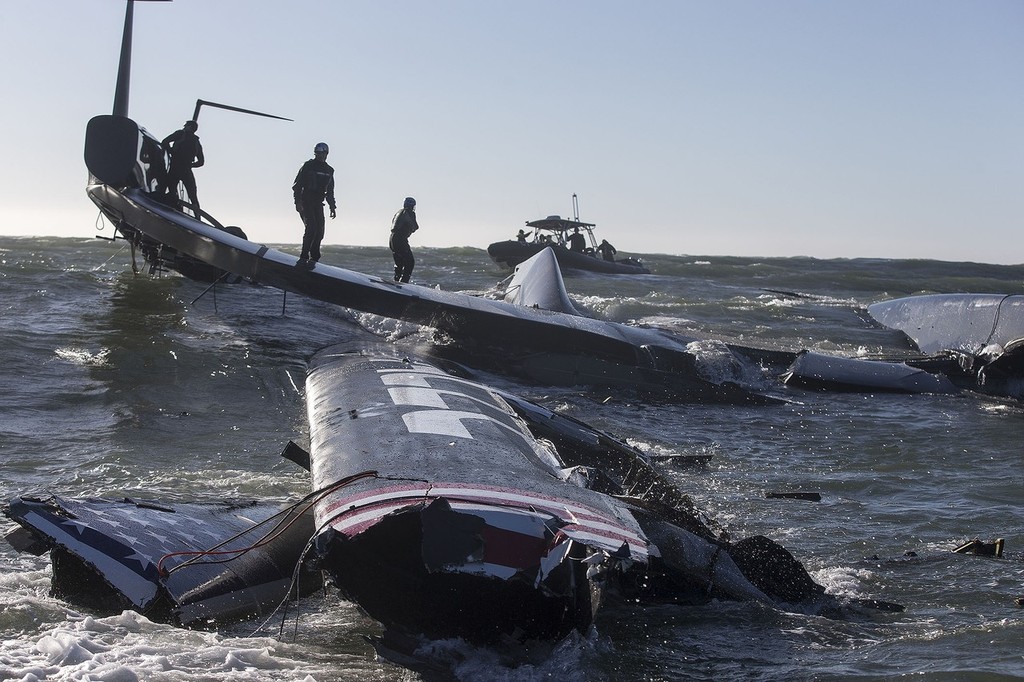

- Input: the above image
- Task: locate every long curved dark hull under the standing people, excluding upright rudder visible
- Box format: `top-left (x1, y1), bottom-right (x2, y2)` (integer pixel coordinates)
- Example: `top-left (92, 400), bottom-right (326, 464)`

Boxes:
top-left (88, 171), bottom-right (764, 403)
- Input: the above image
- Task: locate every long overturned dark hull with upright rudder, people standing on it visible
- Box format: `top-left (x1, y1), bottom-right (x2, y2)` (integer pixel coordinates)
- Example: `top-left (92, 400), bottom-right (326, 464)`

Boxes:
top-left (85, 2), bottom-right (792, 404)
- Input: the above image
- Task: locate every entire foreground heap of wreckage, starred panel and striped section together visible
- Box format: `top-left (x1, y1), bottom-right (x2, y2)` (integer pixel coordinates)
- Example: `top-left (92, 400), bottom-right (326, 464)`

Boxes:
top-left (4, 346), bottom-right (864, 644)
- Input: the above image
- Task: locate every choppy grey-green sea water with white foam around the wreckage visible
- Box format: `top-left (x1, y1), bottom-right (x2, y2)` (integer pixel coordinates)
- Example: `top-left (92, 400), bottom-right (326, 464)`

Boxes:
top-left (0, 238), bottom-right (1024, 681)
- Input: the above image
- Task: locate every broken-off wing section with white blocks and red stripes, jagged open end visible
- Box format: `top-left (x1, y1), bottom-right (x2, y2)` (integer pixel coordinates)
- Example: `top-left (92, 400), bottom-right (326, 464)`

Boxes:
top-left (306, 349), bottom-right (649, 642)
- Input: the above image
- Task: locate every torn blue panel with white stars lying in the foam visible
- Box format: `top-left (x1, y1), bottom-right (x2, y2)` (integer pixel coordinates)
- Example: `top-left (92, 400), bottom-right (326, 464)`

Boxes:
top-left (4, 497), bottom-right (317, 626)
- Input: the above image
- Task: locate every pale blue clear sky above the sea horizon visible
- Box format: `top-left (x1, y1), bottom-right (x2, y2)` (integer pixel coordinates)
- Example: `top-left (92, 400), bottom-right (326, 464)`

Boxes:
top-left (0, 0), bottom-right (1024, 264)
